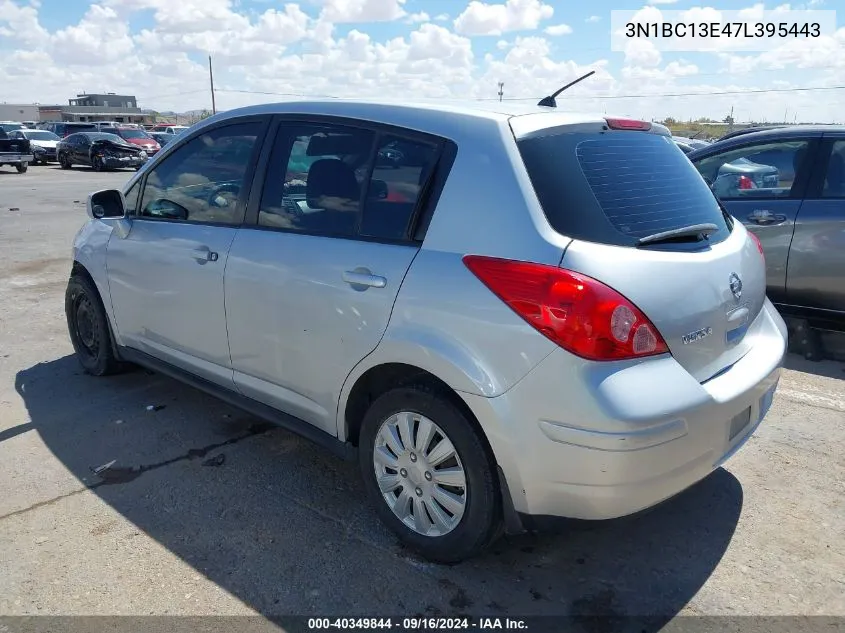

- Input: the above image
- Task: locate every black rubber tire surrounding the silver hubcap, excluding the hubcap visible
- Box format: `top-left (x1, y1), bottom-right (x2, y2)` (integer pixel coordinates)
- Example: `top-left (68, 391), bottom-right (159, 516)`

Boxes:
top-left (358, 384), bottom-right (502, 563)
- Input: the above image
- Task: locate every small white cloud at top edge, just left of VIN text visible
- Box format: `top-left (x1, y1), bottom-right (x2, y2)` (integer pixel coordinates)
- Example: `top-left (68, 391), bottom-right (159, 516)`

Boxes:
top-left (455, 0), bottom-right (554, 35)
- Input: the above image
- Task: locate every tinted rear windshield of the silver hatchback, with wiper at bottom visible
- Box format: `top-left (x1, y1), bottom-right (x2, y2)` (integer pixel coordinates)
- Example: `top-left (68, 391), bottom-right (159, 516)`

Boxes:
top-left (518, 131), bottom-right (730, 246)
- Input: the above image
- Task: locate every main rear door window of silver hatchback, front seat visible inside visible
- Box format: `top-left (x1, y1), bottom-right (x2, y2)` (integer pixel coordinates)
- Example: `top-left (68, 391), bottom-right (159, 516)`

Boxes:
top-left (258, 124), bottom-right (374, 237)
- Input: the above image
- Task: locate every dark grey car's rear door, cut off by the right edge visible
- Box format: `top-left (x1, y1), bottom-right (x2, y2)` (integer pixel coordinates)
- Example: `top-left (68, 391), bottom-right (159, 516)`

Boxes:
top-left (786, 134), bottom-right (845, 318)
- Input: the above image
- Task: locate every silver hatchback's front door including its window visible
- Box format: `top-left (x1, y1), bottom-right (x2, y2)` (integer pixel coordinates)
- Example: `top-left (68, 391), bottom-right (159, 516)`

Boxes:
top-left (107, 118), bottom-right (268, 388)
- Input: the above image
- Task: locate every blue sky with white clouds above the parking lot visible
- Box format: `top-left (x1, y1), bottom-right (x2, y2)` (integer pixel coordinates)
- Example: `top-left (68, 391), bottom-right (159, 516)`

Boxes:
top-left (0, 0), bottom-right (845, 122)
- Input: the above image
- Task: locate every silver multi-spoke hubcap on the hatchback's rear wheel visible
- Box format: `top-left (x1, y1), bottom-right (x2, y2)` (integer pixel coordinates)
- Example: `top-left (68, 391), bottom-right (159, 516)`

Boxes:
top-left (373, 411), bottom-right (468, 536)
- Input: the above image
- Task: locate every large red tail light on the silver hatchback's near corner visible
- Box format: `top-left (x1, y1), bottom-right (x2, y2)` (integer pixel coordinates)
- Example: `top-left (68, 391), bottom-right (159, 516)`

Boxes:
top-left (464, 255), bottom-right (669, 360)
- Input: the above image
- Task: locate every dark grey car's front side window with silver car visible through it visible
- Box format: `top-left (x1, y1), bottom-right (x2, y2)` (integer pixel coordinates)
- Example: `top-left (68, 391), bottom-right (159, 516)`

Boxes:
top-left (695, 140), bottom-right (808, 200)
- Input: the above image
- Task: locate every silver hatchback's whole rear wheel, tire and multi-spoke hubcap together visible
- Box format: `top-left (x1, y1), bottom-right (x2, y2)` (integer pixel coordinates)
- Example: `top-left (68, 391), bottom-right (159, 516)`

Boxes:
top-left (359, 384), bottom-right (501, 563)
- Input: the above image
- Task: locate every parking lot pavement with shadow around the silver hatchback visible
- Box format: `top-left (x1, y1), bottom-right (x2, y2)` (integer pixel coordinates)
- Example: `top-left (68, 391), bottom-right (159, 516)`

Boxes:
top-left (0, 167), bottom-right (845, 618)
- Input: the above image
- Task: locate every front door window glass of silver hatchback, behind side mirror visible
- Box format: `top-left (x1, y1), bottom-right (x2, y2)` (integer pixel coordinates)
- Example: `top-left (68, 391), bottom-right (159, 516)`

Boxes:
top-left (140, 122), bottom-right (263, 224)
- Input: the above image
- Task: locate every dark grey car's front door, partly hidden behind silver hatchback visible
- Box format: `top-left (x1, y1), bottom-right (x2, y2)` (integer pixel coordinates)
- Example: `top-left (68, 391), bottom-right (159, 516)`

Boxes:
top-left (692, 136), bottom-right (818, 303)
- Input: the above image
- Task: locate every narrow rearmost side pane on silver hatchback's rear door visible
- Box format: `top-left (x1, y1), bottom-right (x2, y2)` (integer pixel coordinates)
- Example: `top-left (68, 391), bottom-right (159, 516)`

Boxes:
top-left (360, 136), bottom-right (438, 240)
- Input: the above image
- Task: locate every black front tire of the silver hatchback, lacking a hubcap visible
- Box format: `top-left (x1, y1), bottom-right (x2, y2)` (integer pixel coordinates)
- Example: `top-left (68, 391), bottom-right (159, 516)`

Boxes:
top-left (65, 275), bottom-right (123, 376)
